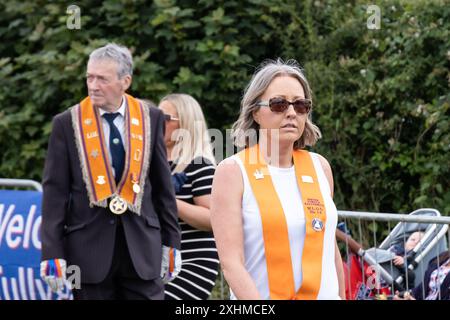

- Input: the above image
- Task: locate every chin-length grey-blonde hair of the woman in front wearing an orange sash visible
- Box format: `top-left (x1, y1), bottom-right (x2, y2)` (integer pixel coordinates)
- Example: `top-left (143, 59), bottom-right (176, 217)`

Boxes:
top-left (231, 58), bottom-right (322, 149)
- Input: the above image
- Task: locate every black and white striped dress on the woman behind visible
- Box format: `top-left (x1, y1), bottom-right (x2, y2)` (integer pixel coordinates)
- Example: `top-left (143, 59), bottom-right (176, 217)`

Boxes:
top-left (165, 158), bottom-right (219, 300)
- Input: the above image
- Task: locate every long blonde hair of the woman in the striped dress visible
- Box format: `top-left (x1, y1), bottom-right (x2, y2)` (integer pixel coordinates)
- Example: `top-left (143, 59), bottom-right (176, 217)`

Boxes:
top-left (161, 93), bottom-right (216, 173)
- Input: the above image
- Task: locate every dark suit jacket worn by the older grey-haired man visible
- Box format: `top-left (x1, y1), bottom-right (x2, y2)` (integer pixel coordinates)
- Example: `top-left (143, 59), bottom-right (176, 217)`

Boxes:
top-left (41, 102), bottom-right (181, 283)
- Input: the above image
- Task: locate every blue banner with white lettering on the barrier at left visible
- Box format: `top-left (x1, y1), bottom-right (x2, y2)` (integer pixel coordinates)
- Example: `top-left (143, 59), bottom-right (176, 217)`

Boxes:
top-left (0, 190), bottom-right (72, 300)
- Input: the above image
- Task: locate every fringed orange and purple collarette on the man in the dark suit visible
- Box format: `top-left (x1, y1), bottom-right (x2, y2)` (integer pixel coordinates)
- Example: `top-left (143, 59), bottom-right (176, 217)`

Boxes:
top-left (71, 94), bottom-right (150, 214)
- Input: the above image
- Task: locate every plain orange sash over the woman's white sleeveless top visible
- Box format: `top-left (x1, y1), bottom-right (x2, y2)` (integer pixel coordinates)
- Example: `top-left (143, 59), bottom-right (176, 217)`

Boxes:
top-left (238, 145), bottom-right (326, 300)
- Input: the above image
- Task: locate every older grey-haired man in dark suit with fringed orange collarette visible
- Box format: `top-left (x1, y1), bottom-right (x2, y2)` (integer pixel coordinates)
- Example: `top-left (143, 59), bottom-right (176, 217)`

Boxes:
top-left (41, 44), bottom-right (181, 299)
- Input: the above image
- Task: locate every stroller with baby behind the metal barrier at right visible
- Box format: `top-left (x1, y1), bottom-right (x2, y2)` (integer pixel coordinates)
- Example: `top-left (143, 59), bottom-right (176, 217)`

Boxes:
top-left (336, 208), bottom-right (448, 299)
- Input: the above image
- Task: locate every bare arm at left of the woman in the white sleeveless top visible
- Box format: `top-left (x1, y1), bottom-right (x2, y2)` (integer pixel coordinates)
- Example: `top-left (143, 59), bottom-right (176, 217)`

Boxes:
top-left (211, 159), bottom-right (261, 300)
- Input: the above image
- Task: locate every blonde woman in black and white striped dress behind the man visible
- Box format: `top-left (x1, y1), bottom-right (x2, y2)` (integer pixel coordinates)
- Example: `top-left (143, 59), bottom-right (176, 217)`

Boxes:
top-left (159, 94), bottom-right (219, 300)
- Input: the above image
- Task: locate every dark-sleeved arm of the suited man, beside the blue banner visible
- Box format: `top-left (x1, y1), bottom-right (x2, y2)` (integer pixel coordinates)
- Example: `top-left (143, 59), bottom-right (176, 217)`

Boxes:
top-left (41, 116), bottom-right (71, 261)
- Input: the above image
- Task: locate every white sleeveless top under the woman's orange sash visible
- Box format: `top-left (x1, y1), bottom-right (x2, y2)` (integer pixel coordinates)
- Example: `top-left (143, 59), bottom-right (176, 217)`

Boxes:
top-left (230, 152), bottom-right (340, 300)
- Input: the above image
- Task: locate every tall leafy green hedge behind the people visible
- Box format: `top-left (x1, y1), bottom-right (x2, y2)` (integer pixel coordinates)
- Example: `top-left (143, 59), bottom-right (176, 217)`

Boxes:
top-left (0, 0), bottom-right (450, 236)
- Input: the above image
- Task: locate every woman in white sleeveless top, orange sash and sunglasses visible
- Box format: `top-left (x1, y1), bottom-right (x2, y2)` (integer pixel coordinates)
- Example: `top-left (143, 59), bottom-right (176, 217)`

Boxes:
top-left (211, 60), bottom-right (345, 299)
